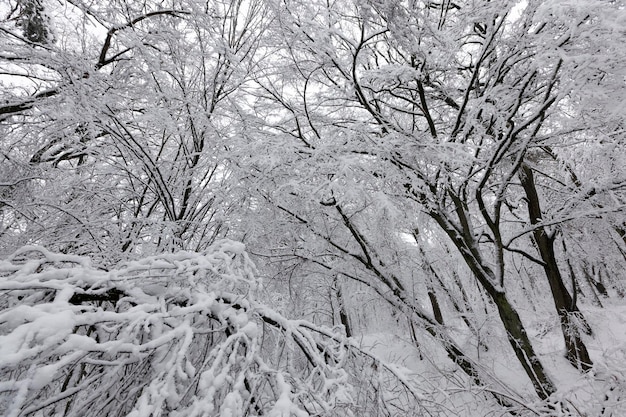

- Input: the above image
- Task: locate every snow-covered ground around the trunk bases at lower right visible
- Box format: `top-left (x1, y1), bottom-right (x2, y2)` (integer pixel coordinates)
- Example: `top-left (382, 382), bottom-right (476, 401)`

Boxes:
top-left (355, 300), bottom-right (626, 417)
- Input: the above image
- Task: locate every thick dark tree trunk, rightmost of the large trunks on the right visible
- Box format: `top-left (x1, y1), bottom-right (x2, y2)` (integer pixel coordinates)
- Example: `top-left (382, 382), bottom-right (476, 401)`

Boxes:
top-left (519, 164), bottom-right (593, 371)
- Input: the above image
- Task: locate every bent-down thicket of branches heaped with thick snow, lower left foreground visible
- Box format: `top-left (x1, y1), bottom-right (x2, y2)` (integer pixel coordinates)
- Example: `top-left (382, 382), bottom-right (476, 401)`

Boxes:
top-left (0, 240), bottom-right (434, 417)
